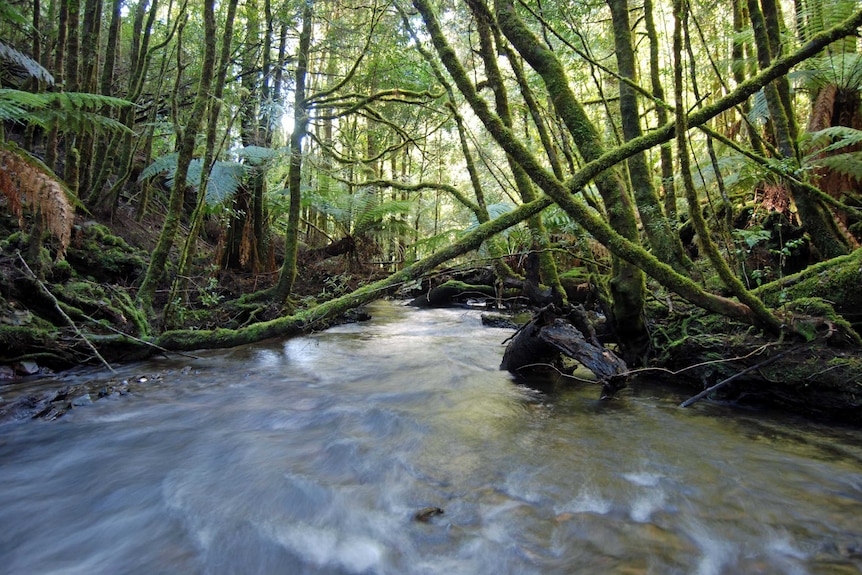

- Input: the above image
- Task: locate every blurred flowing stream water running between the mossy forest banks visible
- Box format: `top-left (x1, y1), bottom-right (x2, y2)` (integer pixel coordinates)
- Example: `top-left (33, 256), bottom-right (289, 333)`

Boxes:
top-left (0, 302), bottom-right (862, 575)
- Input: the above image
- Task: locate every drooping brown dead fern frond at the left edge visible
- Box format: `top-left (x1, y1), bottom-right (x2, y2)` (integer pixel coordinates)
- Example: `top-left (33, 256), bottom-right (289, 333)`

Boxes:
top-left (0, 147), bottom-right (75, 259)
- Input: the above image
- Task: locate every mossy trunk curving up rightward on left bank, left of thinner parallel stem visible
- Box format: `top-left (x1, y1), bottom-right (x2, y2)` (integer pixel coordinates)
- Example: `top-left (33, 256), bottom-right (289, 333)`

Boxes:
top-left (137, 0), bottom-right (216, 312)
